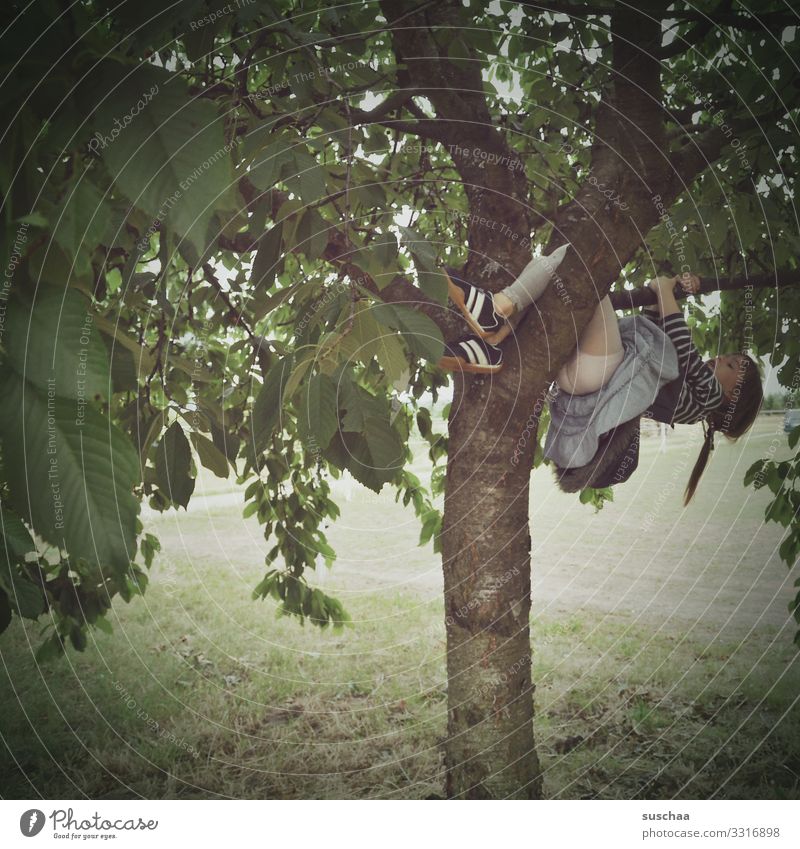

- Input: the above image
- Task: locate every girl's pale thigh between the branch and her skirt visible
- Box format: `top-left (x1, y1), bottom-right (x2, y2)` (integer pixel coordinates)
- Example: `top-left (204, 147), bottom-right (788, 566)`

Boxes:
top-left (556, 296), bottom-right (624, 395)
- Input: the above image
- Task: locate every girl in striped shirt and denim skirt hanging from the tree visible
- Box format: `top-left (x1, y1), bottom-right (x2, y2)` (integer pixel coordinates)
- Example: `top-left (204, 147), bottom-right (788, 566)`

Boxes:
top-left (439, 250), bottom-right (763, 504)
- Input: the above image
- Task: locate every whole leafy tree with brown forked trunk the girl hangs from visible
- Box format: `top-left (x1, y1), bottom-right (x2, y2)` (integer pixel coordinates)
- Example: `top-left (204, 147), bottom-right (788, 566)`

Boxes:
top-left (0, 0), bottom-right (800, 798)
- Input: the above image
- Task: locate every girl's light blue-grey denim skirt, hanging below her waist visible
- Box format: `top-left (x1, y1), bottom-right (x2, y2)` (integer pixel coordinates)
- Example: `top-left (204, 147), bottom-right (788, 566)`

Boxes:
top-left (544, 315), bottom-right (679, 469)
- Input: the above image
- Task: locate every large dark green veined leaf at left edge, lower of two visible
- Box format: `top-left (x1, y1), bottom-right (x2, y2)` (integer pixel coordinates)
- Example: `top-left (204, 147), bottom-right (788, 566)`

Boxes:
top-left (0, 372), bottom-right (139, 570)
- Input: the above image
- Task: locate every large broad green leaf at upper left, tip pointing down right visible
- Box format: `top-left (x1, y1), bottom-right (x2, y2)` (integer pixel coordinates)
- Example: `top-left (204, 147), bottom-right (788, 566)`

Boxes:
top-left (87, 62), bottom-right (234, 255)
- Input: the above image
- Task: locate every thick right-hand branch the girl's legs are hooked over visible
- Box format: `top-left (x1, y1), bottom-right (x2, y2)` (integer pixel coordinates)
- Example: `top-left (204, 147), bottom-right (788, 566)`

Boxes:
top-left (510, 4), bottom-right (679, 397)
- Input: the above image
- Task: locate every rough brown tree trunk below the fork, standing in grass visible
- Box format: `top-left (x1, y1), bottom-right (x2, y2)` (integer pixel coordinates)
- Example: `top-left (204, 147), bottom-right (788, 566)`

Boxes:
top-left (442, 377), bottom-right (542, 799)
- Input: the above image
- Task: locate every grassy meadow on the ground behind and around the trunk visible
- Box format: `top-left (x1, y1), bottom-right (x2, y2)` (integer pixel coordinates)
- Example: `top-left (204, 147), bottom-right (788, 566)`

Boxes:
top-left (0, 420), bottom-right (800, 799)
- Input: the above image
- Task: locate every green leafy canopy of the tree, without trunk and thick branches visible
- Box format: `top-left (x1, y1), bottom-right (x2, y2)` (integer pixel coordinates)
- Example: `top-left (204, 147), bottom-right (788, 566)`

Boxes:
top-left (0, 0), bottom-right (800, 657)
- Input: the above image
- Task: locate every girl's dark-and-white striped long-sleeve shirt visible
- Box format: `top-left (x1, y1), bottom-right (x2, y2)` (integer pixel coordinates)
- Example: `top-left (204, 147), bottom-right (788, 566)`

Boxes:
top-left (642, 307), bottom-right (725, 424)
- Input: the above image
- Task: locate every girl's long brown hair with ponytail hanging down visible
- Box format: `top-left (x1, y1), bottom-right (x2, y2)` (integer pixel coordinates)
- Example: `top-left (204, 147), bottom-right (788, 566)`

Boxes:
top-left (683, 354), bottom-right (764, 507)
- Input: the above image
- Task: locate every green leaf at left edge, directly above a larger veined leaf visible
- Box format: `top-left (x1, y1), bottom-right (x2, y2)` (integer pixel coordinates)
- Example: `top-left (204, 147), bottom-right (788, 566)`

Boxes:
top-left (3, 286), bottom-right (110, 400)
